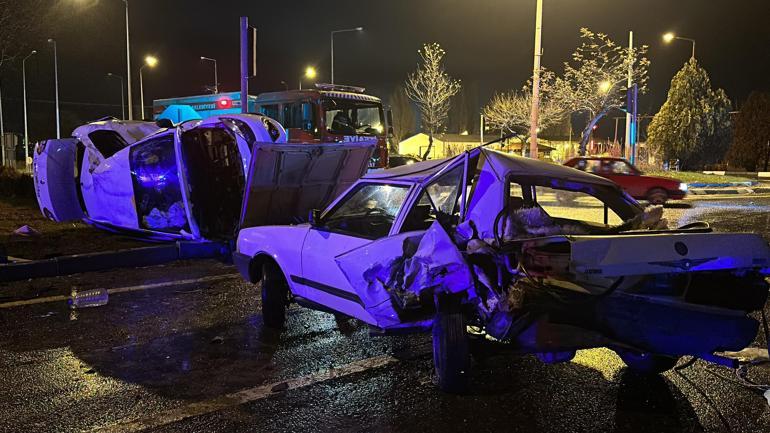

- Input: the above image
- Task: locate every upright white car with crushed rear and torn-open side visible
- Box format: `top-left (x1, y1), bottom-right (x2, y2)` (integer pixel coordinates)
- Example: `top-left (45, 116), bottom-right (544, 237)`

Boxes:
top-left (234, 148), bottom-right (770, 392)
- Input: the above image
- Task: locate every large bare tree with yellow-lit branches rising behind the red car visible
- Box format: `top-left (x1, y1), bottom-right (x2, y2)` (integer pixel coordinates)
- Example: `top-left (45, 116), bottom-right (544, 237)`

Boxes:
top-left (553, 28), bottom-right (650, 155)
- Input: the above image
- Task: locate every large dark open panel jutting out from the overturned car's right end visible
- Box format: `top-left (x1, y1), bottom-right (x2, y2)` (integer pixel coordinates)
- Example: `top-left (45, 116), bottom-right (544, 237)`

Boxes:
top-left (240, 140), bottom-right (377, 228)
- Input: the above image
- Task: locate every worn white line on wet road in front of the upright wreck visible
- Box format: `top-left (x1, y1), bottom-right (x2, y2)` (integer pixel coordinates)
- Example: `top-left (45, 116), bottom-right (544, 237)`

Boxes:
top-left (91, 355), bottom-right (398, 433)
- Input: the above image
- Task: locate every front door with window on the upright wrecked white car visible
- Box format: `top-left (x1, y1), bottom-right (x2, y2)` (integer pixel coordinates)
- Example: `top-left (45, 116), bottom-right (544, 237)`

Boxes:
top-left (290, 182), bottom-right (411, 324)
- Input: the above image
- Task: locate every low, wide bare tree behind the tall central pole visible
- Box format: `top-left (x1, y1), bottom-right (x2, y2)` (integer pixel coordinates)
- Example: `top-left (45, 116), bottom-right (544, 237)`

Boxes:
top-left (483, 70), bottom-right (569, 146)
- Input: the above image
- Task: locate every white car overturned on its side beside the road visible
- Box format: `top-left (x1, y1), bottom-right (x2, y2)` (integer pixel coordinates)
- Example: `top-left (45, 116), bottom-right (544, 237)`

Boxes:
top-left (34, 114), bottom-right (374, 241)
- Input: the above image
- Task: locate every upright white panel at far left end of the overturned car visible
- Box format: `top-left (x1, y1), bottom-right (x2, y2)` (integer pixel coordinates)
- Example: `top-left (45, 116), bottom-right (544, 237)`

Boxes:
top-left (33, 138), bottom-right (85, 222)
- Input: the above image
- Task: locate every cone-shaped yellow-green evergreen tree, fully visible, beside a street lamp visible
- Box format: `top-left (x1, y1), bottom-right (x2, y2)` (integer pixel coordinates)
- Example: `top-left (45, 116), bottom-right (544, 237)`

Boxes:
top-left (647, 57), bottom-right (732, 169)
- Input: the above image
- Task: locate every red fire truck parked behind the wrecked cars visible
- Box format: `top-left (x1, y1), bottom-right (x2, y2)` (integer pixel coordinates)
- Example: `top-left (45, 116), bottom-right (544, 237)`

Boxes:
top-left (254, 84), bottom-right (389, 168)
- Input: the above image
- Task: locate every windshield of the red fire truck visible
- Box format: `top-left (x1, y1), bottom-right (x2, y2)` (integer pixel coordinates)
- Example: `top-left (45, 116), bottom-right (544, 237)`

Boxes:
top-left (322, 98), bottom-right (384, 135)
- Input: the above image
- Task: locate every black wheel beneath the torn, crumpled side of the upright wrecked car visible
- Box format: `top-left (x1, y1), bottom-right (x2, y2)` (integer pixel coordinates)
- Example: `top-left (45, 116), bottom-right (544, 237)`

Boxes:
top-left (433, 296), bottom-right (470, 394)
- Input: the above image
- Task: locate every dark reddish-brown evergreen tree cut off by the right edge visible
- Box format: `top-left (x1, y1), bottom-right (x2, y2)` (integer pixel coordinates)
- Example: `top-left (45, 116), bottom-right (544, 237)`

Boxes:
top-left (728, 91), bottom-right (770, 171)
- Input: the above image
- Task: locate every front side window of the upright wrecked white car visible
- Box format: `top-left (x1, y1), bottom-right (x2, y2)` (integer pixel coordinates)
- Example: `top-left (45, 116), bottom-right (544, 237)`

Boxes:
top-left (322, 184), bottom-right (409, 239)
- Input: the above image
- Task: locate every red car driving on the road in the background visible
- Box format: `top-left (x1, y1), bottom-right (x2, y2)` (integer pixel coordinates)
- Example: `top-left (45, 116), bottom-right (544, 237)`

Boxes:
top-left (564, 156), bottom-right (687, 204)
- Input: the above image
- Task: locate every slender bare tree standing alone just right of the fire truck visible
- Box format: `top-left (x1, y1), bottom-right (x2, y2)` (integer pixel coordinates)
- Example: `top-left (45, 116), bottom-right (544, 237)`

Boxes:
top-left (406, 42), bottom-right (461, 159)
